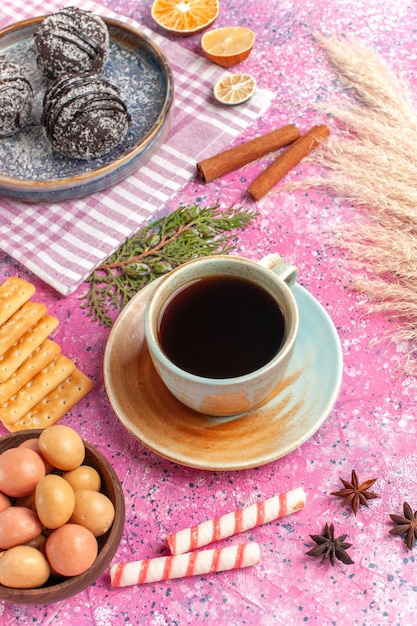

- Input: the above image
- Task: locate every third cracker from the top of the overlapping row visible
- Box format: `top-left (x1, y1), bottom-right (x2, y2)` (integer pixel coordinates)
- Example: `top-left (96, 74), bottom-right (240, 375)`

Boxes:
top-left (0, 315), bottom-right (59, 383)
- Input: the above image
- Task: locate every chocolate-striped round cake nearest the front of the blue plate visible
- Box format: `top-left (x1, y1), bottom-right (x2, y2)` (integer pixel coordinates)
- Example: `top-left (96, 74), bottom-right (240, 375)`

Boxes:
top-left (42, 75), bottom-right (130, 160)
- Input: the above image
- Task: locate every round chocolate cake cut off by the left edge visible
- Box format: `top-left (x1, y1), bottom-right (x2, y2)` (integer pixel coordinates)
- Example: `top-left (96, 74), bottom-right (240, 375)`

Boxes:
top-left (0, 59), bottom-right (33, 137)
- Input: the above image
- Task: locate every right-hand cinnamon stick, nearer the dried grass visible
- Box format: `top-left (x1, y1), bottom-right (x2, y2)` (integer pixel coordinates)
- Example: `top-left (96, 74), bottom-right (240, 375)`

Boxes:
top-left (248, 124), bottom-right (330, 201)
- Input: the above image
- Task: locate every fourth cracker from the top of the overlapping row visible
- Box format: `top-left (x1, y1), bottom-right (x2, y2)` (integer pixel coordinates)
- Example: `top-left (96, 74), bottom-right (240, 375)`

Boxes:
top-left (0, 339), bottom-right (61, 404)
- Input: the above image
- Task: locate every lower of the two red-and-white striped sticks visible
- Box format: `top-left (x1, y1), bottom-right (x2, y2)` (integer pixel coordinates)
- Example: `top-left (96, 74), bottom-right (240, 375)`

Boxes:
top-left (110, 542), bottom-right (261, 587)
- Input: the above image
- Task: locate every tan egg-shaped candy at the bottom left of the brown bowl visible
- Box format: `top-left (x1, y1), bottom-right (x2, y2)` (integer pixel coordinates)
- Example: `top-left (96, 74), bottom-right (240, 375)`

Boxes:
top-left (0, 546), bottom-right (50, 589)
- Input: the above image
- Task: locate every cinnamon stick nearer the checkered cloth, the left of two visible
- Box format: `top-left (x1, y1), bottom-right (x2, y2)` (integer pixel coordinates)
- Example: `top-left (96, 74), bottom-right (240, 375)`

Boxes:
top-left (197, 124), bottom-right (300, 183)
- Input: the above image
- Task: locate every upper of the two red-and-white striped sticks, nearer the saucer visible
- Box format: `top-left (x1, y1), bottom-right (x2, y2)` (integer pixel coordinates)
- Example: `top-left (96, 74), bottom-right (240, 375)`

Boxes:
top-left (166, 487), bottom-right (306, 554)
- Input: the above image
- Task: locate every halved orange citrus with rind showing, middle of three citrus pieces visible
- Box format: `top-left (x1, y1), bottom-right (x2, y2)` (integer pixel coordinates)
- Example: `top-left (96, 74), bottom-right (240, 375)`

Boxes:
top-left (201, 26), bottom-right (255, 67)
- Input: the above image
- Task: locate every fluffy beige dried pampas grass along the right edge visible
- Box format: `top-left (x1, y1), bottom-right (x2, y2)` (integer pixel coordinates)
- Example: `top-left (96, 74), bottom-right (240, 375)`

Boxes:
top-left (285, 35), bottom-right (417, 372)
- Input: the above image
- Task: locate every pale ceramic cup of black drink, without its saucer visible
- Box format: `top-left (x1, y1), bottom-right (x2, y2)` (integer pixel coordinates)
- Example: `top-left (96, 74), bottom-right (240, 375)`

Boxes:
top-left (145, 254), bottom-right (299, 417)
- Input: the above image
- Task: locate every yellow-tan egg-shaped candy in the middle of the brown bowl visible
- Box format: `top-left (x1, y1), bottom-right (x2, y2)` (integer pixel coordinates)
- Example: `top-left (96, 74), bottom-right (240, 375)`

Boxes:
top-left (35, 474), bottom-right (75, 529)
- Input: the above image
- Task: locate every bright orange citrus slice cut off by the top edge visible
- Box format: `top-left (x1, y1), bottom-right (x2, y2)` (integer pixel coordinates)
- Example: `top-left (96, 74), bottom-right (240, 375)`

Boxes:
top-left (151, 0), bottom-right (219, 35)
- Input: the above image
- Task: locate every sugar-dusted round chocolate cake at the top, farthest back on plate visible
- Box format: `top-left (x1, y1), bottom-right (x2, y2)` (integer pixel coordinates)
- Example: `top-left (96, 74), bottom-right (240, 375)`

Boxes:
top-left (35, 7), bottom-right (109, 80)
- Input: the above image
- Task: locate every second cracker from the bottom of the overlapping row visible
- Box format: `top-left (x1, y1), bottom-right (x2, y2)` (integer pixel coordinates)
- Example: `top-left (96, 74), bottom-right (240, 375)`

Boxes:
top-left (0, 354), bottom-right (75, 425)
